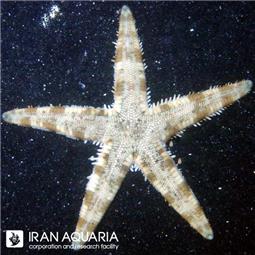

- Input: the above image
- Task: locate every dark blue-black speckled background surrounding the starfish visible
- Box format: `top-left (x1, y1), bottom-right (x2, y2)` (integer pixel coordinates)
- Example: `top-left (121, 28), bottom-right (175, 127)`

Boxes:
top-left (1, 2), bottom-right (255, 255)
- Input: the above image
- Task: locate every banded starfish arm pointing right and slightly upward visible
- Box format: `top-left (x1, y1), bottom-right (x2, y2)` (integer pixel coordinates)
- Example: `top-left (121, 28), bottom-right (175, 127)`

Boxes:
top-left (150, 80), bottom-right (252, 141)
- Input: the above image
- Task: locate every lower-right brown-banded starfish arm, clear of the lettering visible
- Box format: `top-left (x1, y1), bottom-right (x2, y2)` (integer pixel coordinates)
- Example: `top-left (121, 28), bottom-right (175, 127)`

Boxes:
top-left (136, 144), bottom-right (213, 239)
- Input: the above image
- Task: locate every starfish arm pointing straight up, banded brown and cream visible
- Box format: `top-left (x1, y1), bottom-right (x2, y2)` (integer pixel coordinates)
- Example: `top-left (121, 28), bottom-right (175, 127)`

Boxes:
top-left (113, 6), bottom-right (147, 112)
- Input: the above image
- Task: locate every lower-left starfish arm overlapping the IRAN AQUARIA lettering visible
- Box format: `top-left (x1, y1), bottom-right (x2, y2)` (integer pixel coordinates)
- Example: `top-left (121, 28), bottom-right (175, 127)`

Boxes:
top-left (73, 139), bottom-right (132, 249)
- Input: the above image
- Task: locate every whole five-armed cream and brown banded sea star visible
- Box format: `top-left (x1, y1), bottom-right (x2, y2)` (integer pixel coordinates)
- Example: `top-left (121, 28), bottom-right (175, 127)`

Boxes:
top-left (3, 6), bottom-right (252, 248)
